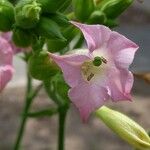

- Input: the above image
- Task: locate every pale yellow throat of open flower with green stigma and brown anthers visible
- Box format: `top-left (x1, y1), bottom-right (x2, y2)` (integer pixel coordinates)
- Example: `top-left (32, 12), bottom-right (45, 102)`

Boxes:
top-left (81, 56), bottom-right (107, 81)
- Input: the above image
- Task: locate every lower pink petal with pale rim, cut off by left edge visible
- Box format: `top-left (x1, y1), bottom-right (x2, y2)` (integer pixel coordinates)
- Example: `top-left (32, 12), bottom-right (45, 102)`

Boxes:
top-left (0, 65), bottom-right (13, 92)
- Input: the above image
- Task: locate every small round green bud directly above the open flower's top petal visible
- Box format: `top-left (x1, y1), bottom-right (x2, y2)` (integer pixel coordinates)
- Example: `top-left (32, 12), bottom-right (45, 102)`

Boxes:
top-left (88, 10), bottom-right (106, 24)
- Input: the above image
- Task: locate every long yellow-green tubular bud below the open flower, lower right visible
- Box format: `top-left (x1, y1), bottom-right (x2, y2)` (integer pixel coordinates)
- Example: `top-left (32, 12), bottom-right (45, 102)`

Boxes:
top-left (96, 106), bottom-right (150, 150)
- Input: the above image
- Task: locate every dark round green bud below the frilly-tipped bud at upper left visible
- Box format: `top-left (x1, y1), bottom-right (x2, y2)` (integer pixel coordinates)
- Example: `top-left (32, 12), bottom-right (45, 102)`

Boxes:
top-left (12, 28), bottom-right (32, 48)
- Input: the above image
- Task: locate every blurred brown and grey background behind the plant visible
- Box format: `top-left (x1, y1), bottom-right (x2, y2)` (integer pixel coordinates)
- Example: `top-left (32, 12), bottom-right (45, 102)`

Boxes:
top-left (0, 0), bottom-right (150, 150)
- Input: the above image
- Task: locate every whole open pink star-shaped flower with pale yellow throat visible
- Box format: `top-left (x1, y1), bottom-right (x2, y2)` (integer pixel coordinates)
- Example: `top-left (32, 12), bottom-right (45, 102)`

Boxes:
top-left (50, 22), bottom-right (138, 121)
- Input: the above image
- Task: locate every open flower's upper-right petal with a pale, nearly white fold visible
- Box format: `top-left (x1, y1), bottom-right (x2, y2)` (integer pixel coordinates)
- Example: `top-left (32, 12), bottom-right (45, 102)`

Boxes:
top-left (107, 32), bottom-right (139, 68)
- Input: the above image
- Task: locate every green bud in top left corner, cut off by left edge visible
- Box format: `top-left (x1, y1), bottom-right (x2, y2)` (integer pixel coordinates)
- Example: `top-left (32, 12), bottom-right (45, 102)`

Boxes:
top-left (0, 0), bottom-right (14, 32)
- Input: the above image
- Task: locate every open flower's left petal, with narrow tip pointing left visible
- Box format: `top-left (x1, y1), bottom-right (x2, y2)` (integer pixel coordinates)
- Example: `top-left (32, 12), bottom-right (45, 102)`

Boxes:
top-left (50, 53), bottom-right (89, 87)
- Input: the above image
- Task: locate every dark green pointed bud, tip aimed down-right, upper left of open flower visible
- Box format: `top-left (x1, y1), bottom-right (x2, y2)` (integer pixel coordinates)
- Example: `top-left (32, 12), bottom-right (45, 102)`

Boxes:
top-left (36, 17), bottom-right (66, 41)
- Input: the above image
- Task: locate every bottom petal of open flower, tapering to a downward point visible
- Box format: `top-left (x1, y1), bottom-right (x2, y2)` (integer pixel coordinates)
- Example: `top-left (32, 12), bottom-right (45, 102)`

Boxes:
top-left (69, 82), bottom-right (109, 122)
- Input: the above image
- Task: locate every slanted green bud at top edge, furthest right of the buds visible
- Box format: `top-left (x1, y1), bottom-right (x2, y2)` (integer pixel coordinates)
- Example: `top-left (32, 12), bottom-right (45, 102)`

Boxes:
top-left (97, 0), bottom-right (133, 19)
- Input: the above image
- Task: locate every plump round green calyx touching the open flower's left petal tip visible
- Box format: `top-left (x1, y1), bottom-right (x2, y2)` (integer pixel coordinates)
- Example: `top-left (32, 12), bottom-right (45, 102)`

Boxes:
top-left (28, 51), bottom-right (59, 80)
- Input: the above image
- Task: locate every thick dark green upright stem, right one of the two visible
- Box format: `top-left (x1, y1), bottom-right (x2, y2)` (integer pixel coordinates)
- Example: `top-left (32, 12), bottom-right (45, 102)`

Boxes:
top-left (58, 108), bottom-right (67, 150)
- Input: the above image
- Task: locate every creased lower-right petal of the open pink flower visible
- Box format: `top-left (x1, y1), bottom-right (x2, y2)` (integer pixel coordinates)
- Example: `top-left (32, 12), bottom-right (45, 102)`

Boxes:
top-left (108, 68), bottom-right (134, 102)
